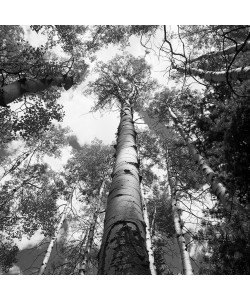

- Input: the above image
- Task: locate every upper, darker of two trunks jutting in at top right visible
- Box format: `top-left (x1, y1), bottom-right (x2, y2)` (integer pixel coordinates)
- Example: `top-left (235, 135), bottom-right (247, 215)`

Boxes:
top-left (189, 42), bottom-right (250, 64)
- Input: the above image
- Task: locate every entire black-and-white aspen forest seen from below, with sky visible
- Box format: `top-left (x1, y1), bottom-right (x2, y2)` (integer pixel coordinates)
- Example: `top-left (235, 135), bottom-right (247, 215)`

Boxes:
top-left (0, 25), bottom-right (250, 275)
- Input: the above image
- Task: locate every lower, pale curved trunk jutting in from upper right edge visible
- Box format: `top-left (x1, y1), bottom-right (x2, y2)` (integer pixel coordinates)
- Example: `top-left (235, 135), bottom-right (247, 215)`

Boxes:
top-left (173, 66), bottom-right (250, 82)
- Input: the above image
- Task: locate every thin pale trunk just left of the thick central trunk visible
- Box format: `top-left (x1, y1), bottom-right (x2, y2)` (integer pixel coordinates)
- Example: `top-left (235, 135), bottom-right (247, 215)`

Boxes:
top-left (79, 180), bottom-right (105, 275)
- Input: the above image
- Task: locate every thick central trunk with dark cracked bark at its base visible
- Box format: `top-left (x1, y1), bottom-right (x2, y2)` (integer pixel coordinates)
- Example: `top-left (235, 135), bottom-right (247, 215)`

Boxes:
top-left (98, 101), bottom-right (151, 275)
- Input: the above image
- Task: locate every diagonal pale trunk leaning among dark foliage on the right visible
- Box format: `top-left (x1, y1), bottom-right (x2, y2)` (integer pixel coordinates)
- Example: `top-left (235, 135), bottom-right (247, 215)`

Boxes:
top-left (168, 108), bottom-right (243, 211)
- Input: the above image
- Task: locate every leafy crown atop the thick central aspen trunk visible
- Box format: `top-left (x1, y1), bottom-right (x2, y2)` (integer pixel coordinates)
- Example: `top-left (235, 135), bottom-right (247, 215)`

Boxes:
top-left (87, 54), bottom-right (155, 110)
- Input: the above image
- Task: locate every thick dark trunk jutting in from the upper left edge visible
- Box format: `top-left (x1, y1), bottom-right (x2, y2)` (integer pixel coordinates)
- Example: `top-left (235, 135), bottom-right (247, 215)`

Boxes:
top-left (0, 75), bottom-right (73, 107)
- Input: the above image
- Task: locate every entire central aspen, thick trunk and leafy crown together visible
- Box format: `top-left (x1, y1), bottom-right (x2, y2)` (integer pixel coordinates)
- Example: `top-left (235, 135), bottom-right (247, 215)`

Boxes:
top-left (89, 55), bottom-right (154, 275)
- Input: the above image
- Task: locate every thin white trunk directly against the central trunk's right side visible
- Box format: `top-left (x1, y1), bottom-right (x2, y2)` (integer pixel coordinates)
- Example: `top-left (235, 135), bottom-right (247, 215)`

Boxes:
top-left (141, 188), bottom-right (157, 275)
